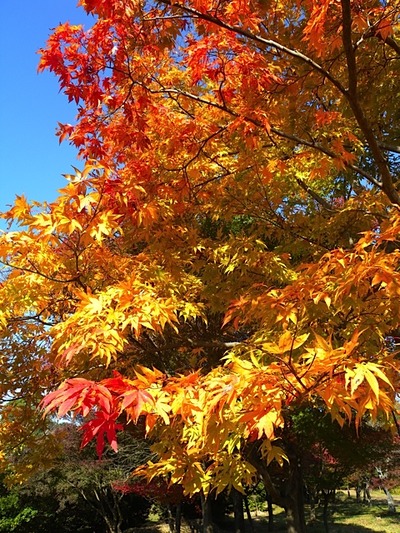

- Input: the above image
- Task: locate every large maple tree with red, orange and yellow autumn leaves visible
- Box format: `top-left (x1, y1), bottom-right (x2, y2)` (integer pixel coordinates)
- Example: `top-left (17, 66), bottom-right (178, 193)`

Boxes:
top-left (0, 0), bottom-right (400, 531)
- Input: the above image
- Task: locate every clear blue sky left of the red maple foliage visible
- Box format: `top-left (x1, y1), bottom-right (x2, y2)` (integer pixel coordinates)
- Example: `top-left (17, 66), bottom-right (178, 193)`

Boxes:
top-left (0, 0), bottom-right (93, 216)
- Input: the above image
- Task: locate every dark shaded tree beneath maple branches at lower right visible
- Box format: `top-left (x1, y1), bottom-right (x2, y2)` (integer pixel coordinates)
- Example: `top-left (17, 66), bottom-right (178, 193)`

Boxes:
top-left (264, 404), bottom-right (397, 531)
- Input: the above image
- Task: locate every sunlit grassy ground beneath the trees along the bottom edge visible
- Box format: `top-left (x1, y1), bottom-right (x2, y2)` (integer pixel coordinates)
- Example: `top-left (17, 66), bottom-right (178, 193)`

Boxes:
top-left (134, 491), bottom-right (400, 533)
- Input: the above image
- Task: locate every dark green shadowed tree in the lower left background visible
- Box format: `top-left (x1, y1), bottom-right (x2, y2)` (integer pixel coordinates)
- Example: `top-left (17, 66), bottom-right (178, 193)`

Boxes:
top-left (0, 423), bottom-right (151, 533)
